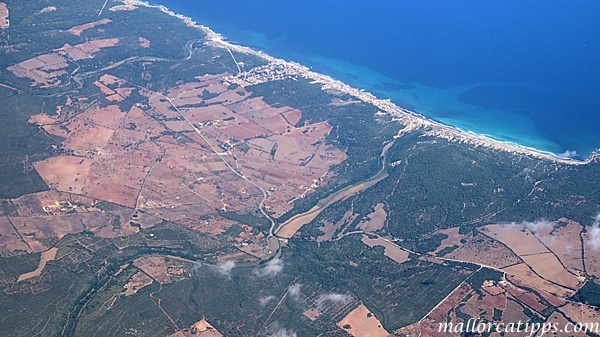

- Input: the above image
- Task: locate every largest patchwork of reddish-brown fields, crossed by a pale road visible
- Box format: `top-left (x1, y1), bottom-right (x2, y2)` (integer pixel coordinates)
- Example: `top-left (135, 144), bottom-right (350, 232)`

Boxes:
top-left (32, 69), bottom-right (345, 227)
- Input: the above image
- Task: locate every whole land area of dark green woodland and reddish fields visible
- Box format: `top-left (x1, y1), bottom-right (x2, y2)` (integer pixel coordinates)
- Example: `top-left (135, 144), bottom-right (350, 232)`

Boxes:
top-left (0, 0), bottom-right (600, 337)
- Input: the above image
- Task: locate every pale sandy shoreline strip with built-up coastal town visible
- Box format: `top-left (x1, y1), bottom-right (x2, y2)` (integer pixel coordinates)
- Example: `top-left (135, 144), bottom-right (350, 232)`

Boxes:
top-left (121, 0), bottom-right (600, 165)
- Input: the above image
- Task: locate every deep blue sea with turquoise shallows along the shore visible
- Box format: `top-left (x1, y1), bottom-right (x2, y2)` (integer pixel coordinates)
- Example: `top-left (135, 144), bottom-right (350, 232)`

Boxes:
top-left (152, 0), bottom-right (600, 158)
